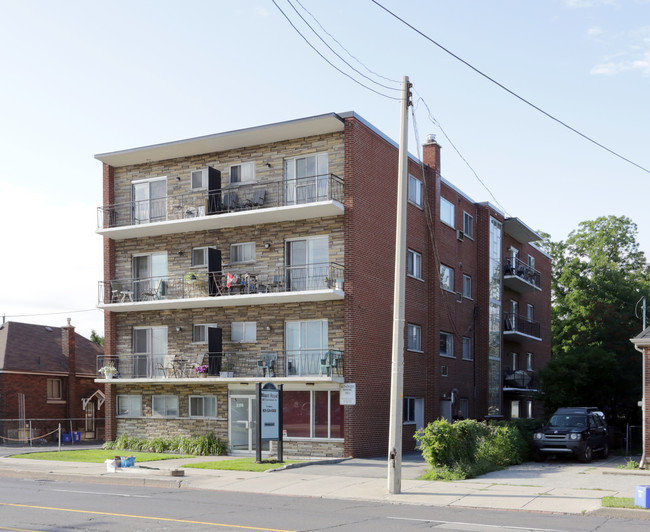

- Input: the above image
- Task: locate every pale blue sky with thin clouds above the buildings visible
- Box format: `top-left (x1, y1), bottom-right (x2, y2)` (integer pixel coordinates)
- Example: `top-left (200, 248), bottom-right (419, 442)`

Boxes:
top-left (0, 0), bottom-right (650, 337)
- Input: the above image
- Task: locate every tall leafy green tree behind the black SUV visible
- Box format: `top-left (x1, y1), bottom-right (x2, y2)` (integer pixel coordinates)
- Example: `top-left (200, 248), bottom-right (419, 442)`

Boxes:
top-left (540, 216), bottom-right (650, 421)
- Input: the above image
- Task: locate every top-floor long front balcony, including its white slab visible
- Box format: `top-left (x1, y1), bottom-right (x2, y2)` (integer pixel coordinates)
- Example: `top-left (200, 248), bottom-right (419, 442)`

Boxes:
top-left (97, 174), bottom-right (343, 240)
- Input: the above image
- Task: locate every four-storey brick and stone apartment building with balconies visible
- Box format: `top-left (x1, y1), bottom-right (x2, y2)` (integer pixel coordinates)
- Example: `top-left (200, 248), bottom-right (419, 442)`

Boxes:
top-left (96, 113), bottom-right (550, 456)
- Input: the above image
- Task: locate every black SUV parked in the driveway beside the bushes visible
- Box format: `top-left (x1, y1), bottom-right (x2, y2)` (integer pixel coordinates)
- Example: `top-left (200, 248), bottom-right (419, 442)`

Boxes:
top-left (533, 406), bottom-right (609, 463)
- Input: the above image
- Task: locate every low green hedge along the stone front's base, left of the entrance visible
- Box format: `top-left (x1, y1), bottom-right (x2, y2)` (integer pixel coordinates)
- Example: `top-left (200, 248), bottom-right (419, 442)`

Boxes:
top-left (103, 432), bottom-right (228, 456)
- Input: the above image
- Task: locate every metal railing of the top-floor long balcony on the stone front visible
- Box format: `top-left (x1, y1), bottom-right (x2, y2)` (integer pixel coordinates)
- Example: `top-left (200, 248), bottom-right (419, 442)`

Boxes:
top-left (97, 174), bottom-right (343, 230)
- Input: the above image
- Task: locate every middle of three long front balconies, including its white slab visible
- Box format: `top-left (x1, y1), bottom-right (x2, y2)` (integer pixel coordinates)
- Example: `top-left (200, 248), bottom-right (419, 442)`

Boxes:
top-left (98, 262), bottom-right (344, 312)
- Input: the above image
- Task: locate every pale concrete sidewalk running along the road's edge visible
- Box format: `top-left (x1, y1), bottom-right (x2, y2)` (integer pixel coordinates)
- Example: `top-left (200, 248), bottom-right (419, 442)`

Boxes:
top-left (0, 449), bottom-right (650, 519)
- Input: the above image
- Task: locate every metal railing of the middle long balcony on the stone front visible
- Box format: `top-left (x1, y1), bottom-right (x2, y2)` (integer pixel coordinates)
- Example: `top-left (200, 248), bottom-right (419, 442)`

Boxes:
top-left (99, 263), bottom-right (343, 305)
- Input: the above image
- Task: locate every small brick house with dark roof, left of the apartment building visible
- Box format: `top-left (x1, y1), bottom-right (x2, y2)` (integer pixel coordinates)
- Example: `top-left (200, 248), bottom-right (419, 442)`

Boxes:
top-left (0, 320), bottom-right (104, 441)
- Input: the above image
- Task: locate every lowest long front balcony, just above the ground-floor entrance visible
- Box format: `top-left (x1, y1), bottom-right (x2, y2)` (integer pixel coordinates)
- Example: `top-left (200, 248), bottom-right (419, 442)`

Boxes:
top-left (97, 349), bottom-right (344, 383)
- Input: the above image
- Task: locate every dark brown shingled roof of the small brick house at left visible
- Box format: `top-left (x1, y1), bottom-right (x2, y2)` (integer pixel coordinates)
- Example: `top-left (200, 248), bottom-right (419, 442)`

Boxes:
top-left (0, 321), bottom-right (104, 375)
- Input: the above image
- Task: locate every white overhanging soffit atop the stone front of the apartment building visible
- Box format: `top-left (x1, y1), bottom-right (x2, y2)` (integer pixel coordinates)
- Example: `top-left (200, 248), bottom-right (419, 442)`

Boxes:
top-left (95, 113), bottom-right (344, 167)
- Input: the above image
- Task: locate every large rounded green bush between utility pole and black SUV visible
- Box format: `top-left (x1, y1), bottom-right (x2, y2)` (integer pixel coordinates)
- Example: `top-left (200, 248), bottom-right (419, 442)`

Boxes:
top-left (415, 419), bottom-right (529, 480)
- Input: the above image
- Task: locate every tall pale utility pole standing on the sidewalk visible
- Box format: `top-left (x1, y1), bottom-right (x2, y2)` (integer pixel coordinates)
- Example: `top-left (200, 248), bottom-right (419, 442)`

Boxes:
top-left (388, 76), bottom-right (411, 493)
